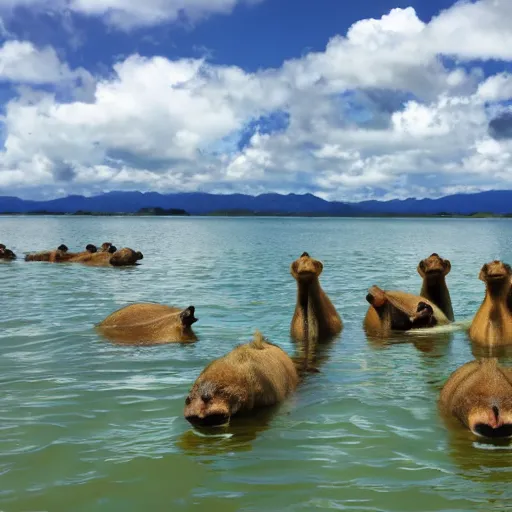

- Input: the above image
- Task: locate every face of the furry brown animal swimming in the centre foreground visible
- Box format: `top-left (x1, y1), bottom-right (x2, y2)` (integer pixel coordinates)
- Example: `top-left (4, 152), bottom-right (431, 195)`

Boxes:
top-left (184, 379), bottom-right (232, 427)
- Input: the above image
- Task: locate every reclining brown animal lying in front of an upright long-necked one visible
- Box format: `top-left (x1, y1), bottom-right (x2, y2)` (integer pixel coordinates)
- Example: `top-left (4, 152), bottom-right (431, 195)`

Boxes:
top-left (364, 286), bottom-right (450, 335)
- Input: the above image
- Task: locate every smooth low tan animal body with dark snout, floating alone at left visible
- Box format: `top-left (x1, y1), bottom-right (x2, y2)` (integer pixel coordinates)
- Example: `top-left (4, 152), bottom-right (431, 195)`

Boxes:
top-left (96, 304), bottom-right (197, 344)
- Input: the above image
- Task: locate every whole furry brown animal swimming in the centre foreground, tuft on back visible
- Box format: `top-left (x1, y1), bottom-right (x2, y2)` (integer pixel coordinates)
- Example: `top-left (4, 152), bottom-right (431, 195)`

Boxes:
top-left (184, 331), bottom-right (299, 426)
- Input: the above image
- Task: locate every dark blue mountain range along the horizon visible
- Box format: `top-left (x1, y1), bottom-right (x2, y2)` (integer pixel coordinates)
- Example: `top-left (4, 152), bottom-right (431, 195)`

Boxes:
top-left (0, 190), bottom-right (512, 217)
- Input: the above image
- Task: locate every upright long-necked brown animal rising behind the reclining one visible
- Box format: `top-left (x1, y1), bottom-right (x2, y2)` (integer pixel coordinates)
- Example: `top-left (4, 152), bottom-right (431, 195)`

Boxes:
top-left (417, 253), bottom-right (455, 322)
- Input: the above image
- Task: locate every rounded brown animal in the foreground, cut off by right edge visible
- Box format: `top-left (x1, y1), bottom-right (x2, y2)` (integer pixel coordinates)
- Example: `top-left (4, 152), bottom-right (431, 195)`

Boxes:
top-left (438, 358), bottom-right (512, 438)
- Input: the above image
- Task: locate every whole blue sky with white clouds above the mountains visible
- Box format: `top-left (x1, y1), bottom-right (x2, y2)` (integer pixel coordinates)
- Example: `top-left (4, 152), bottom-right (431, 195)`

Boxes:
top-left (0, 0), bottom-right (512, 201)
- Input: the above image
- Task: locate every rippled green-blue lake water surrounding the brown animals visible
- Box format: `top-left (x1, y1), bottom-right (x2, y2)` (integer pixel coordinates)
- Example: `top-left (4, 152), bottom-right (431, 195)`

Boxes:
top-left (0, 217), bottom-right (512, 512)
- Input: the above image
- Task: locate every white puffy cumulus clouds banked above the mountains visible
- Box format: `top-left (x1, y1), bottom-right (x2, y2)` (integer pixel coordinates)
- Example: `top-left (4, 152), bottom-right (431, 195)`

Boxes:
top-left (0, 0), bottom-right (512, 200)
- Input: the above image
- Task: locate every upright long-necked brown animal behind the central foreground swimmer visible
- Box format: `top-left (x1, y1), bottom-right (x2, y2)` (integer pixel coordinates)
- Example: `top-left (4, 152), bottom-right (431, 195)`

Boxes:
top-left (290, 252), bottom-right (343, 342)
